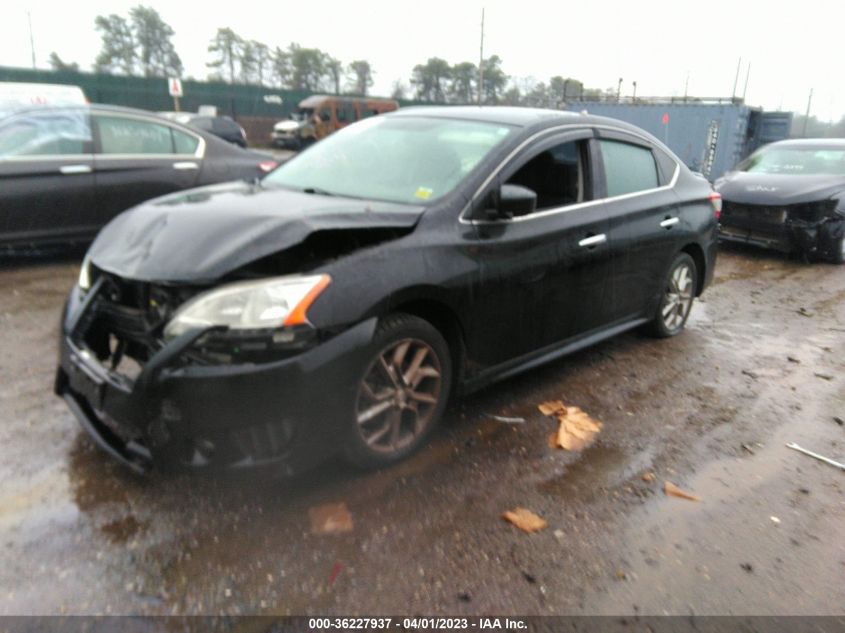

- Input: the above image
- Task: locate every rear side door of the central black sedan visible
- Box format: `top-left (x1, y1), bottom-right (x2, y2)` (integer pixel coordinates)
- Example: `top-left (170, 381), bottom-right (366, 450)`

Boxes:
top-left (596, 129), bottom-right (680, 321)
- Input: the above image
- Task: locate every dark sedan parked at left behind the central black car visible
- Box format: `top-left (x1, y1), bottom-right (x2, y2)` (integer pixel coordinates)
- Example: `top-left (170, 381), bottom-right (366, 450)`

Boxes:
top-left (0, 105), bottom-right (275, 250)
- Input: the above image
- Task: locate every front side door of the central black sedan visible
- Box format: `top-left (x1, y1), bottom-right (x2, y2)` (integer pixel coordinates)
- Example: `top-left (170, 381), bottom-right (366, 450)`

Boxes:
top-left (467, 130), bottom-right (613, 365)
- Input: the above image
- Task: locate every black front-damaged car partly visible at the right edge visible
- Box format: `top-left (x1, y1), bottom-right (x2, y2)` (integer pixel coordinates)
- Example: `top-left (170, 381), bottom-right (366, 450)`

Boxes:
top-left (716, 139), bottom-right (845, 264)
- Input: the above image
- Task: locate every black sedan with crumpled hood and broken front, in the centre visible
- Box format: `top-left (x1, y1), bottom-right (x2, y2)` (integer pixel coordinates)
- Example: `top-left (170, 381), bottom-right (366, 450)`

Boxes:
top-left (55, 107), bottom-right (720, 472)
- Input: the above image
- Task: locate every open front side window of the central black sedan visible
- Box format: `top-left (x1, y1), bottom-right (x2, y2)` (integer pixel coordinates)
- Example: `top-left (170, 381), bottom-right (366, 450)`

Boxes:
top-left (507, 141), bottom-right (586, 212)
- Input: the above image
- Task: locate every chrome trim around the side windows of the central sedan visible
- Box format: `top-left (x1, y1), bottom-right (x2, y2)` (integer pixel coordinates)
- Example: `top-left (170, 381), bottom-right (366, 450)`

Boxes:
top-left (458, 123), bottom-right (681, 225)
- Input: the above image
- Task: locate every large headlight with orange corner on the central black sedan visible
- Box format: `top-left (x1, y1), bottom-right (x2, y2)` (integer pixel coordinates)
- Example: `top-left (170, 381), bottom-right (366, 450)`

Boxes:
top-left (164, 275), bottom-right (331, 339)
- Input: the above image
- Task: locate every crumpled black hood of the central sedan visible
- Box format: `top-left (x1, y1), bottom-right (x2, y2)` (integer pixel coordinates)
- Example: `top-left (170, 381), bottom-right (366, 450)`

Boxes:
top-left (88, 182), bottom-right (424, 283)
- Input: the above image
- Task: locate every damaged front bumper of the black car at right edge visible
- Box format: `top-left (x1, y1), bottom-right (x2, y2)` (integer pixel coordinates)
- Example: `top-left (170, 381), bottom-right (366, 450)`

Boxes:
top-left (719, 201), bottom-right (845, 259)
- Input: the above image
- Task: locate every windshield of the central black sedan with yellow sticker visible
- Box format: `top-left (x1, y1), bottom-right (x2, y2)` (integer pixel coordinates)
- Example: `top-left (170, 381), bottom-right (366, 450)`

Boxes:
top-left (264, 117), bottom-right (514, 203)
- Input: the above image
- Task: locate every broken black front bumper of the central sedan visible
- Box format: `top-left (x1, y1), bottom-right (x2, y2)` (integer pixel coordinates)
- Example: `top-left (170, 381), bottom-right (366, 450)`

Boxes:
top-left (55, 288), bottom-right (376, 474)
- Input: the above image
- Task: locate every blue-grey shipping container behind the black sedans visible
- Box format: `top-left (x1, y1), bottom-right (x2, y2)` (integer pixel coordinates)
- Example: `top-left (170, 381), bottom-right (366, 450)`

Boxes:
top-left (566, 100), bottom-right (792, 181)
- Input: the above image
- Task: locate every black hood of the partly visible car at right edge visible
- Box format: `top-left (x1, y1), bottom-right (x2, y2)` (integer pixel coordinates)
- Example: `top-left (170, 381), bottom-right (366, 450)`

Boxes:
top-left (716, 171), bottom-right (845, 206)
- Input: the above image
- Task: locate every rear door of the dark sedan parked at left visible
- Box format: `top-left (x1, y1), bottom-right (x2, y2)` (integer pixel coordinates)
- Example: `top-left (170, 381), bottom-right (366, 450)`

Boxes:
top-left (92, 112), bottom-right (204, 224)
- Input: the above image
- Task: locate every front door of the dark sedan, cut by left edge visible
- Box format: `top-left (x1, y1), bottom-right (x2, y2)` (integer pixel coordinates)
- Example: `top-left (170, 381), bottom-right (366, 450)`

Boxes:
top-left (0, 107), bottom-right (98, 243)
